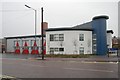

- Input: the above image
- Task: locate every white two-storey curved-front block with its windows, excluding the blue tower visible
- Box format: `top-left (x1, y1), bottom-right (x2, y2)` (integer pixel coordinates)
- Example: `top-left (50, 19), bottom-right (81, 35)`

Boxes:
top-left (46, 28), bottom-right (92, 54)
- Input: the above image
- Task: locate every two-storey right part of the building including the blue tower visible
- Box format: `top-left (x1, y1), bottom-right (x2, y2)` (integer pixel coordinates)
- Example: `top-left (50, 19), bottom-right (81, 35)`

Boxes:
top-left (46, 16), bottom-right (113, 55)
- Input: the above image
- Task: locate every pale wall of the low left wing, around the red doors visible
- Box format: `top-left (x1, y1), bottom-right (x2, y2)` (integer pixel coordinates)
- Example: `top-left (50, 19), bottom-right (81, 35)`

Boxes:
top-left (7, 38), bottom-right (41, 53)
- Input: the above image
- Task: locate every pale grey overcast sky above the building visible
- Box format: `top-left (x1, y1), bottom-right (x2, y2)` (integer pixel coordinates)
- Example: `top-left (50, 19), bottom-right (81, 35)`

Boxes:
top-left (0, 0), bottom-right (118, 37)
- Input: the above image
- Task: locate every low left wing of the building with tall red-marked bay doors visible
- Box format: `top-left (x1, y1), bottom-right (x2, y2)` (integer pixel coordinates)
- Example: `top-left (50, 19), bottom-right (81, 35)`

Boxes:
top-left (5, 35), bottom-right (45, 54)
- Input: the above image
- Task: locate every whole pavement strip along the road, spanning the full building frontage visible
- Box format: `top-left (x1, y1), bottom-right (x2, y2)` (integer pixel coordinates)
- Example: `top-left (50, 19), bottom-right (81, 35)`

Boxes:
top-left (2, 54), bottom-right (120, 63)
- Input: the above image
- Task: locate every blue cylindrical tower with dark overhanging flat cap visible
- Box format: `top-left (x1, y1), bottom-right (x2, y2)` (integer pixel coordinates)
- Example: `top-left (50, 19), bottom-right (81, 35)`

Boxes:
top-left (92, 16), bottom-right (109, 55)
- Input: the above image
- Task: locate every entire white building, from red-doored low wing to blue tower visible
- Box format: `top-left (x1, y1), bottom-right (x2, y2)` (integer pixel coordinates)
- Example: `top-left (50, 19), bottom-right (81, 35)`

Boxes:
top-left (5, 16), bottom-right (113, 55)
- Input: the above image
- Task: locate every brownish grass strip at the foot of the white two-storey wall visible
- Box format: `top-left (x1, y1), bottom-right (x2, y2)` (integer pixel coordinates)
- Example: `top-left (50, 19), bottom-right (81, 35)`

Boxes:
top-left (45, 54), bottom-right (92, 58)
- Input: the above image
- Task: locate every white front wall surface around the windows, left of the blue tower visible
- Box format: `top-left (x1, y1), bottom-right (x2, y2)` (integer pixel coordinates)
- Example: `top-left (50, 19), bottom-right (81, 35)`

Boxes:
top-left (46, 30), bottom-right (92, 54)
